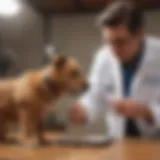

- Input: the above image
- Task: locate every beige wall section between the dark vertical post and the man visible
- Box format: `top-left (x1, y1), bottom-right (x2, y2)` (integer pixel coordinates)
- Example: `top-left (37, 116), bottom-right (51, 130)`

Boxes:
top-left (53, 14), bottom-right (100, 72)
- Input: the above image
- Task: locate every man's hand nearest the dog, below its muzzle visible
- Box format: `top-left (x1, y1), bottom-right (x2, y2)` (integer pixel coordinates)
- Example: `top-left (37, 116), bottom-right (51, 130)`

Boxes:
top-left (69, 104), bottom-right (87, 124)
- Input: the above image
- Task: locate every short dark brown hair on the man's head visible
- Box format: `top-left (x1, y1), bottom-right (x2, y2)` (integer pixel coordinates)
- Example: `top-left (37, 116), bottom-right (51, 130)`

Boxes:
top-left (98, 2), bottom-right (144, 33)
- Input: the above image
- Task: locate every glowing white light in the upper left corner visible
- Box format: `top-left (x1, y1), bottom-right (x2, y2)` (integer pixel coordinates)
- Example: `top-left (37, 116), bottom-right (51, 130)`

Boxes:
top-left (0, 0), bottom-right (20, 16)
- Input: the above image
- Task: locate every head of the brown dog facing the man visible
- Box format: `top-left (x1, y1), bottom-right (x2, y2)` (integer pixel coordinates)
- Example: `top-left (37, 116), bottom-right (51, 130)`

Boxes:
top-left (43, 55), bottom-right (88, 94)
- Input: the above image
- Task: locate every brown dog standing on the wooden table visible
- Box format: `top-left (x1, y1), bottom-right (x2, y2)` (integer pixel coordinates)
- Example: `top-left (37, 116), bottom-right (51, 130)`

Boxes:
top-left (0, 56), bottom-right (86, 146)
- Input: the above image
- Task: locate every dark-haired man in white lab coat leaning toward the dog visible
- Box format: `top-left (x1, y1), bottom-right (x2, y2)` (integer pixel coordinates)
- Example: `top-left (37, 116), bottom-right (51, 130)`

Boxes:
top-left (69, 2), bottom-right (160, 138)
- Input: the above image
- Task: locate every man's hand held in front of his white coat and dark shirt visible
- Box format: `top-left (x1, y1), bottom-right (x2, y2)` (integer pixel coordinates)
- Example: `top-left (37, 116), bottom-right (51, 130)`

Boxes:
top-left (112, 99), bottom-right (153, 122)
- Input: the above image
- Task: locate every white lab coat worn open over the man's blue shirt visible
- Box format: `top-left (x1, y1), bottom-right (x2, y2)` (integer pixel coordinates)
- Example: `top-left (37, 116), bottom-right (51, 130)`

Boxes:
top-left (80, 37), bottom-right (160, 138)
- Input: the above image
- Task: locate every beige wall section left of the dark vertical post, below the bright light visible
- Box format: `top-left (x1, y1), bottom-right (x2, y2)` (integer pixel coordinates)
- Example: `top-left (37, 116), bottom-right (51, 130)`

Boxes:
top-left (0, 1), bottom-right (43, 73)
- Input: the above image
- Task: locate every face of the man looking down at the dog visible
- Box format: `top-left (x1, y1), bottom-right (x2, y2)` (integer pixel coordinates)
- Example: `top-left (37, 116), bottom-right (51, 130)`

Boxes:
top-left (102, 25), bottom-right (143, 62)
